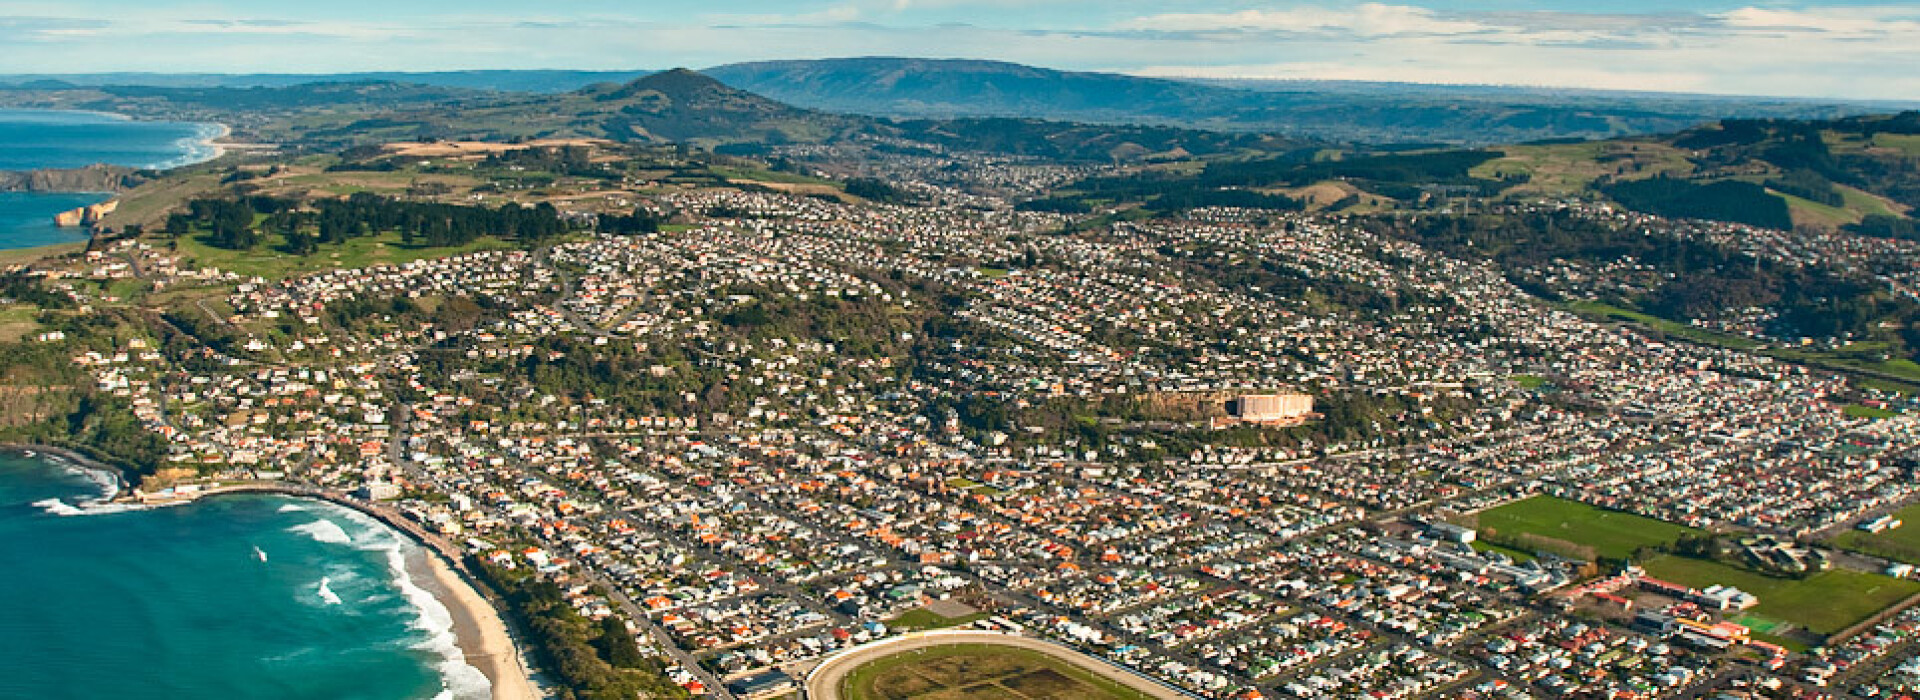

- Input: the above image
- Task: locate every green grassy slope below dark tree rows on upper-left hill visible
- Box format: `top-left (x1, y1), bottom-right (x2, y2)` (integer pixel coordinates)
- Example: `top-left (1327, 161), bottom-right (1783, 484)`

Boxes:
top-left (168, 227), bottom-right (516, 280)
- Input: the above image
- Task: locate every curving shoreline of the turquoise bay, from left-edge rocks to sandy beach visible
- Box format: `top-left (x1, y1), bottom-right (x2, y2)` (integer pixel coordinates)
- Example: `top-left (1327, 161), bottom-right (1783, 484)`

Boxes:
top-left (0, 452), bottom-right (543, 700)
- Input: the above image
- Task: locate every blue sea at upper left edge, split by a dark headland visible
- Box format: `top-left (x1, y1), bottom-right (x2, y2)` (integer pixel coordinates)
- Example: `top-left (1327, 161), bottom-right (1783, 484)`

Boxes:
top-left (0, 109), bottom-right (221, 249)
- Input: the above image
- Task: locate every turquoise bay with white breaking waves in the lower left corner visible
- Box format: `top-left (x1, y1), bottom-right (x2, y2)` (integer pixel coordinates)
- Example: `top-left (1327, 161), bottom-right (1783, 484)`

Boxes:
top-left (0, 453), bottom-right (488, 700)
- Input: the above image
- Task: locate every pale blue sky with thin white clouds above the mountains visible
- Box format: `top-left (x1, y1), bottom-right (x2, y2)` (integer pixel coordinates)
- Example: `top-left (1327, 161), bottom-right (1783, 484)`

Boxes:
top-left (0, 0), bottom-right (1920, 102)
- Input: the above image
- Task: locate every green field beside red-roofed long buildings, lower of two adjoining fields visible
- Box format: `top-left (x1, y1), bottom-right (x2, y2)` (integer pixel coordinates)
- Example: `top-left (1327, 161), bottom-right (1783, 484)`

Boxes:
top-left (1642, 556), bottom-right (1920, 635)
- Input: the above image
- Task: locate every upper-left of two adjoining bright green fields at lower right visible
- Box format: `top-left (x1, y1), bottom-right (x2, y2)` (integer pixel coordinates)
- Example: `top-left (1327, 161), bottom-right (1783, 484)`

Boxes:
top-left (1473, 497), bottom-right (1695, 558)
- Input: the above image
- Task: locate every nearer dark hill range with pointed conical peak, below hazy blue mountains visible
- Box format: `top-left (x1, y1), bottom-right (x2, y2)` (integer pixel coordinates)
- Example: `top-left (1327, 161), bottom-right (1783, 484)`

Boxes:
top-left (0, 69), bottom-right (1298, 161)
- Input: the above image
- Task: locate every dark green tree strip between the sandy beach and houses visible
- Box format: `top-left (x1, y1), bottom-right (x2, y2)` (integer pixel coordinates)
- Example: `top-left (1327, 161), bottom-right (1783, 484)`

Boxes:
top-left (470, 560), bottom-right (687, 700)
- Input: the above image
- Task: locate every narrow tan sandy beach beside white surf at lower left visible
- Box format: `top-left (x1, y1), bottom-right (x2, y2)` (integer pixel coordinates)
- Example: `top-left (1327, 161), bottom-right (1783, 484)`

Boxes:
top-left (409, 548), bottom-right (541, 700)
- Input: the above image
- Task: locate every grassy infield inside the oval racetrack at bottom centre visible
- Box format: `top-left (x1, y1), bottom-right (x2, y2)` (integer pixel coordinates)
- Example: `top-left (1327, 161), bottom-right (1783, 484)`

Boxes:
top-left (841, 644), bottom-right (1148, 700)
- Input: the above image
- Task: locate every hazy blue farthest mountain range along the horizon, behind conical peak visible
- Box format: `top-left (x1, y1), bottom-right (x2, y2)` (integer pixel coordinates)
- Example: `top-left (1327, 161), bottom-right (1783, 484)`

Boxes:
top-left (0, 58), bottom-right (1920, 144)
